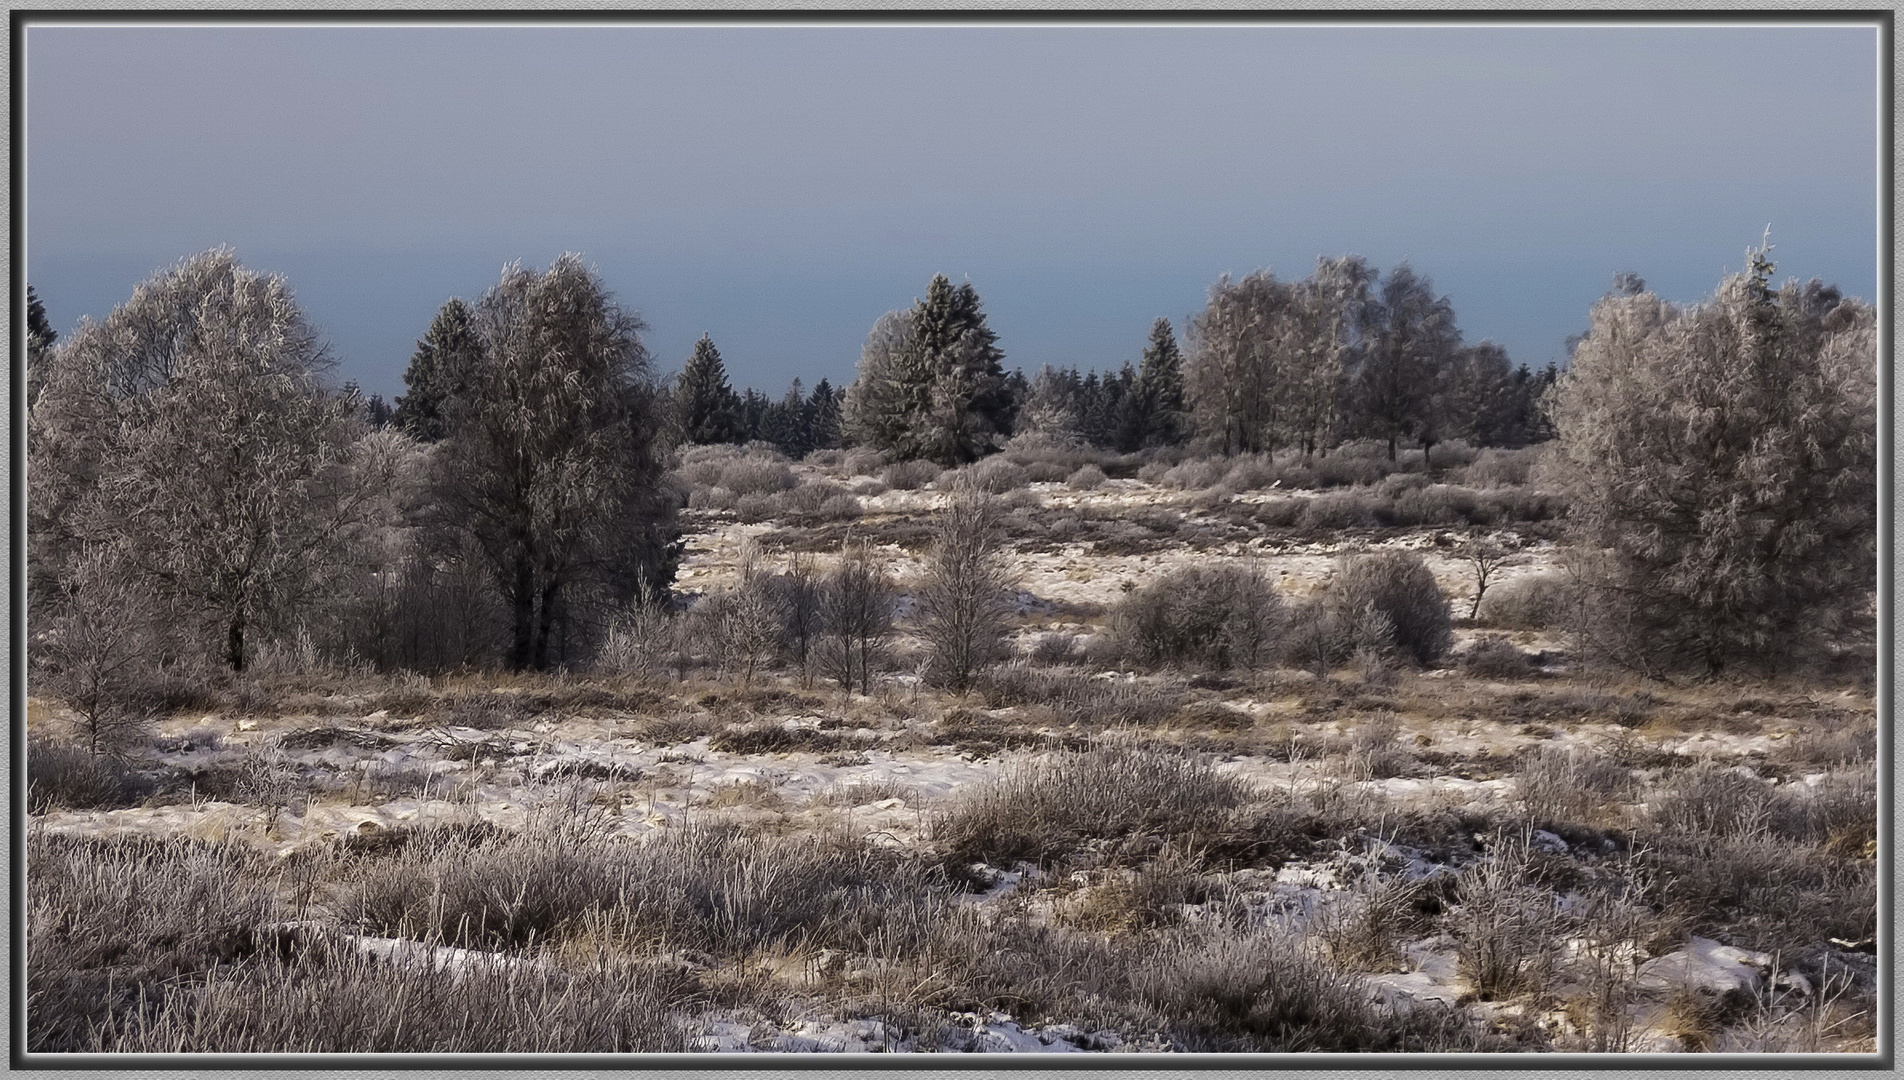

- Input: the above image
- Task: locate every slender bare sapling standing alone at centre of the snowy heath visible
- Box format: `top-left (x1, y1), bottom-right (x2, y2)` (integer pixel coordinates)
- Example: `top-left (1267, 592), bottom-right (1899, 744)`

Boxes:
top-left (918, 484), bottom-right (1011, 693)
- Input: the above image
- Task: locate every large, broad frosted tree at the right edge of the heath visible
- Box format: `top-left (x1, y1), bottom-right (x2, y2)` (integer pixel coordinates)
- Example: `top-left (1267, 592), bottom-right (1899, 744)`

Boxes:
top-left (1554, 248), bottom-right (1877, 674)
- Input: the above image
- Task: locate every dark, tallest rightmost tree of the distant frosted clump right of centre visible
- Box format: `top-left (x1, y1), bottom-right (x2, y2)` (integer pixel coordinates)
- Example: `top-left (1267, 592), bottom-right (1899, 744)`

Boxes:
top-left (1352, 263), bottom-right (1460, 461)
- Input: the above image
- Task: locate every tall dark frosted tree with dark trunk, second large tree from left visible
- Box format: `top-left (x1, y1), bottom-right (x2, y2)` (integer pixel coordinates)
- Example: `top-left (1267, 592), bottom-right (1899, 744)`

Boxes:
top-left (434, 253), bottom-right (678, 670)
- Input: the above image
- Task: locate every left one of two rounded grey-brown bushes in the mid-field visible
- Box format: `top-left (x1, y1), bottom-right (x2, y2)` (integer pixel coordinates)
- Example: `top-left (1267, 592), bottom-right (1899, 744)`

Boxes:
top-left (1110, 566), bottom-right (1283, 669)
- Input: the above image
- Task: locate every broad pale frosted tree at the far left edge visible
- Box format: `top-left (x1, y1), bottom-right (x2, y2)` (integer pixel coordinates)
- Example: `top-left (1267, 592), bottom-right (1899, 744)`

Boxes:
top-left (29, 248), bottom-right (371, 670)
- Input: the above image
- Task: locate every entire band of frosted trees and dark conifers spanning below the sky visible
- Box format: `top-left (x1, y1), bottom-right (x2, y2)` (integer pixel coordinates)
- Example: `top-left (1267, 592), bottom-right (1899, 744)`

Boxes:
top-left (27, 239), bottom-right (1875, 697)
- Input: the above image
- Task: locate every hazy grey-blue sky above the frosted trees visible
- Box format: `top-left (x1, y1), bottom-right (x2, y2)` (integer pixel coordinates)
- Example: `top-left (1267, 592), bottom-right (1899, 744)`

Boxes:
top-left (25, 23), bottom-right (1881, 398)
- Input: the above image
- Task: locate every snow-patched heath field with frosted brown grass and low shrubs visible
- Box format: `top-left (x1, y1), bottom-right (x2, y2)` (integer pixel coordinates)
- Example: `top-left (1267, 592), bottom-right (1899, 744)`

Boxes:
top-left (27, 450), bottom-right (1877, 1053)
